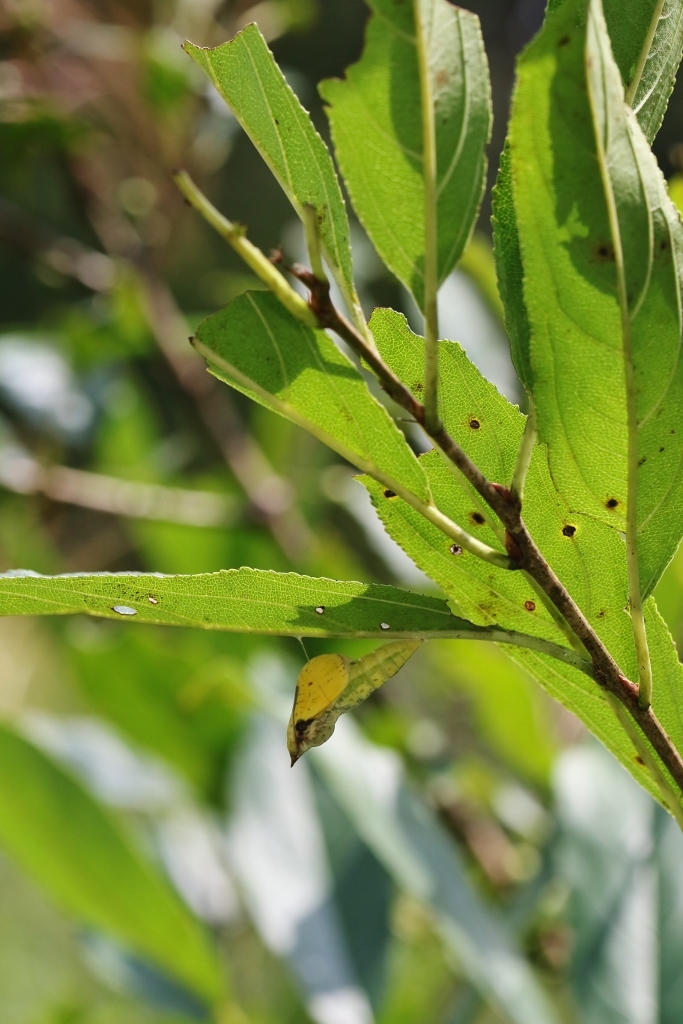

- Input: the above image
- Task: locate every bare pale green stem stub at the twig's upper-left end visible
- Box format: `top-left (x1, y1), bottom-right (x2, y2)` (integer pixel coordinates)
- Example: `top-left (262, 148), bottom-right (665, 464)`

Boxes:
top-left (173, 171), bottom-right (316, 327)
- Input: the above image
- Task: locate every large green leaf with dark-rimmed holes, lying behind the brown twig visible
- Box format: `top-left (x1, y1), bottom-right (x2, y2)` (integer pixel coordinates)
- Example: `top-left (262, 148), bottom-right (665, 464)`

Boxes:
top-left (364, 309), bottom-right (683, 799)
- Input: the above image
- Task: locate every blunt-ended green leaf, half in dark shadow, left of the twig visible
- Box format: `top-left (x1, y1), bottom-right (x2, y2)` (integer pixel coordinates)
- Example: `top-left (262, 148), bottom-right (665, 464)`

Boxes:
top-left (196, 292), bottom-right (429, 503)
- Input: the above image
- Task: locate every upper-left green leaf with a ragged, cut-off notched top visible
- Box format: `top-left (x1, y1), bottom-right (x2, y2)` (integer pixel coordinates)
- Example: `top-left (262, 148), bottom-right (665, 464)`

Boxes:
top-left (184, 25), bottom-right (362, 316)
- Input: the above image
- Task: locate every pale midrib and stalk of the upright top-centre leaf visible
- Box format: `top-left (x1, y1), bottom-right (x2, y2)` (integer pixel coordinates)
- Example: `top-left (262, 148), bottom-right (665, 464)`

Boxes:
top-left (413, 0), bottom-right (440, 430)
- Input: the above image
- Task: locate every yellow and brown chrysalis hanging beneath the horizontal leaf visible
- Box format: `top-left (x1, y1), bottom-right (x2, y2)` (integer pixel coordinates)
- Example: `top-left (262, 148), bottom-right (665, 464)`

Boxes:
top-left (287, 640), bottom-right (422, 765)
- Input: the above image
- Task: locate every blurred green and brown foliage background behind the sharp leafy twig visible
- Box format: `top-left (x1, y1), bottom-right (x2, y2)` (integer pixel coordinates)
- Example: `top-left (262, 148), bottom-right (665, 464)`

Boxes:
top-left (0, 0), bottom-right (683, 1024)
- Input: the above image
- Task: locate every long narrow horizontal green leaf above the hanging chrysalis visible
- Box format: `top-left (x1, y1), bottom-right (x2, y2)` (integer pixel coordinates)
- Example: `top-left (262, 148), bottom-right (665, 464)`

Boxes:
top-left (0, 568), bottom-right (491, 639)
